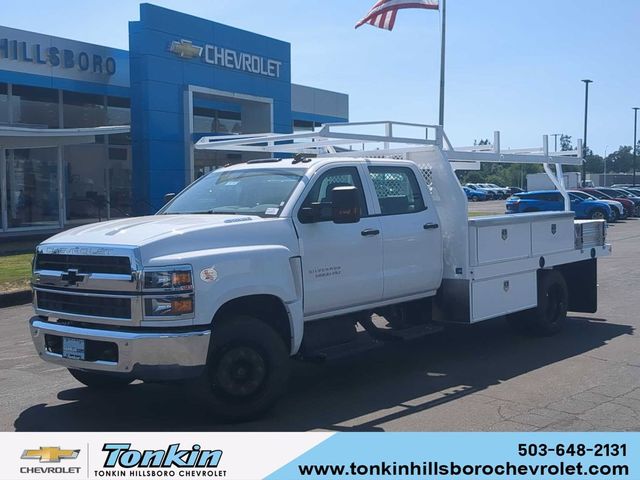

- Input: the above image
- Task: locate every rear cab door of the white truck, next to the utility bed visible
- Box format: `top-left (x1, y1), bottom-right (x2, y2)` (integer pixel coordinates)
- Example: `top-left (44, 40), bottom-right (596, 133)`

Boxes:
top-left (369, 166), bottom-right (442, 300)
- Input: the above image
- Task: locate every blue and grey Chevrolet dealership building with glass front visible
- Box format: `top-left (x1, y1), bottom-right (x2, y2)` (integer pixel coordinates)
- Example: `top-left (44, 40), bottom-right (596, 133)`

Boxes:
top-left (0, 4), bottom-right (349, 238)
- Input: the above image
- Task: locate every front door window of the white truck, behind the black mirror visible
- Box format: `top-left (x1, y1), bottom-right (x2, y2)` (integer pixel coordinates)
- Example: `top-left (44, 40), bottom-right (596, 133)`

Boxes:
top-left (302, 167), bottom-right (368, 222)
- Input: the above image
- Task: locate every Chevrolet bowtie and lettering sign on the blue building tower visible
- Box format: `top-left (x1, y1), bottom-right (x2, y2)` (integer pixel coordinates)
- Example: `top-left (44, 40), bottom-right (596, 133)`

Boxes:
top-left (169, 40), bottom-right (282, 78)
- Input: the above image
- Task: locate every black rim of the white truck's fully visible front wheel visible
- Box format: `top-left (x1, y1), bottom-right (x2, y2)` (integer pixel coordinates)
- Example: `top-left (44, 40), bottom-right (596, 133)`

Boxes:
top-left (214, 346), bottom-right (267, 399)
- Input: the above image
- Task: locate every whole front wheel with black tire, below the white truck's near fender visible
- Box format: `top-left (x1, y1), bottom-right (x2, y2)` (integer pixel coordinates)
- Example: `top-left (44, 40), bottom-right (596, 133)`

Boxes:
top-left (207, 315), bottom-right (291, 421)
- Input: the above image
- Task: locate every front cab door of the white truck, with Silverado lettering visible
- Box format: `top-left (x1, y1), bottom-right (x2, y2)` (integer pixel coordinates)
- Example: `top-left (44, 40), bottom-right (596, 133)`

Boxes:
top-left (294, 167), bottom-right (382, 316)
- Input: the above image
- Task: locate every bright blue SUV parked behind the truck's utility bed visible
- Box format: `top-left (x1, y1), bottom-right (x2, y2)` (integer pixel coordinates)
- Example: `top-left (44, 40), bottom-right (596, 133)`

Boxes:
top-left (507, 190), bottom-right (614, 221)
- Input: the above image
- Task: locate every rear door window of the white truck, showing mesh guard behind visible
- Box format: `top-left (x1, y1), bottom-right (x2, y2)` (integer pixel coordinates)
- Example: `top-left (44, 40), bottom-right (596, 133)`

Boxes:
top-left (369, 167), bottom-right (425, 215)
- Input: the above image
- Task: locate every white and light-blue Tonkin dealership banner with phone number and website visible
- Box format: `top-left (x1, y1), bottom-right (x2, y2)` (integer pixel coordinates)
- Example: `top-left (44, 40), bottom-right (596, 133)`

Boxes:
top-left (0, 432), bottom-right (640, 480)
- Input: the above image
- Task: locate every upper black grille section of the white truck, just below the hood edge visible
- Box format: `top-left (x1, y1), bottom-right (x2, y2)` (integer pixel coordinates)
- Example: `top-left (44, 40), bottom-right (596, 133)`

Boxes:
top-left (35, 253), bottom-right (131, 275)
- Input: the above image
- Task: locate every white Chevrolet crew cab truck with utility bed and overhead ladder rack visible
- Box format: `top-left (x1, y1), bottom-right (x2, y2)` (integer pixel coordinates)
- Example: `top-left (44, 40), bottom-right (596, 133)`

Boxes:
top-left (30, 122), bottom-right (611, 418)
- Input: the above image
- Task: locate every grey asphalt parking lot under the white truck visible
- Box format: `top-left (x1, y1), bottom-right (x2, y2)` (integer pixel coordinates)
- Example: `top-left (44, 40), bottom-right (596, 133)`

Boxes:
top-left (0, 214), bottom-right (640, 431)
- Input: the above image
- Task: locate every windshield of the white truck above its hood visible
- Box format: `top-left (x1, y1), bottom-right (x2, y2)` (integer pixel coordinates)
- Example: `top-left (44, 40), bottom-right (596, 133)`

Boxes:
top-left (158, 168), bottom-right (305, 217)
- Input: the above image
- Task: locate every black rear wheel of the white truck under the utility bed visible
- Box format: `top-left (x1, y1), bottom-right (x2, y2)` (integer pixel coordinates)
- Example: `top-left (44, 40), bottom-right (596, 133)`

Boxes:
top-left (507, 270), bottom-right (569, 336)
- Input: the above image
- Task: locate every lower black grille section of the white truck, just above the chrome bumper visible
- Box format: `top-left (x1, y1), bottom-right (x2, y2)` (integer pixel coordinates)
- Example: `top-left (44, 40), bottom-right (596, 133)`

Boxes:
top-left (36, 291), bottom-right (131, 319)
